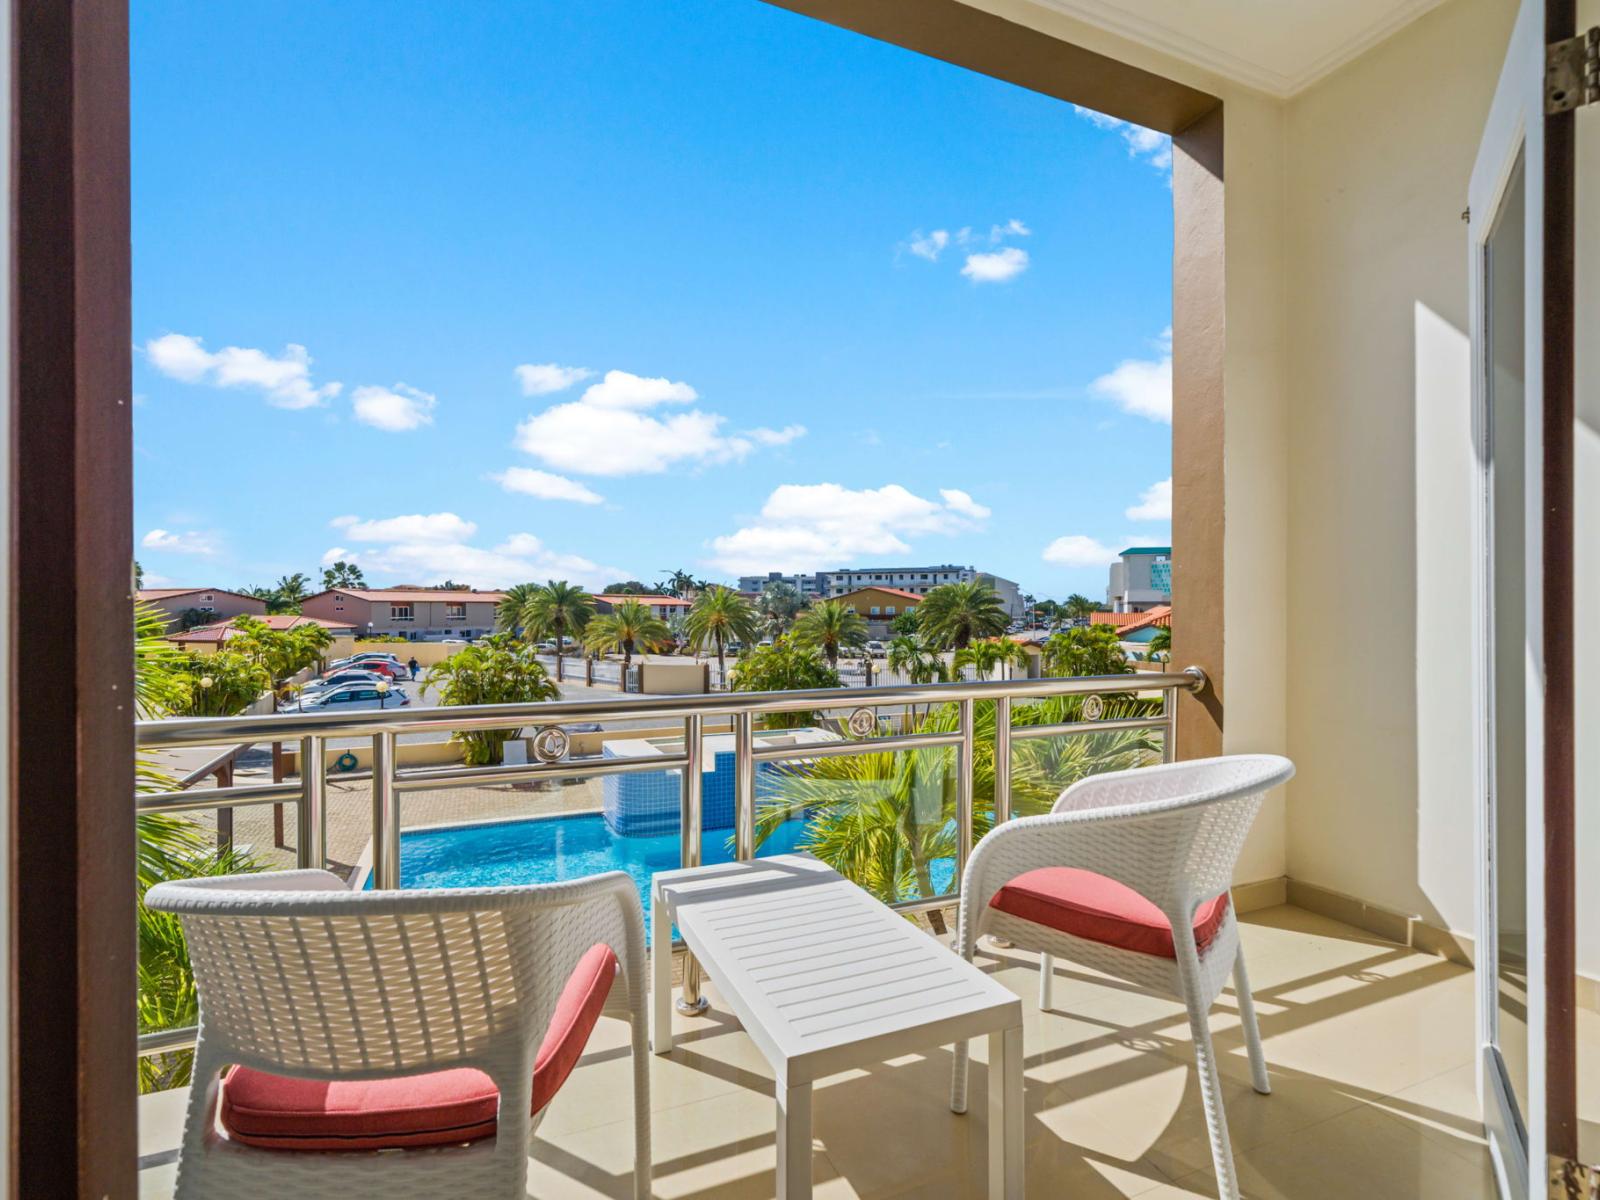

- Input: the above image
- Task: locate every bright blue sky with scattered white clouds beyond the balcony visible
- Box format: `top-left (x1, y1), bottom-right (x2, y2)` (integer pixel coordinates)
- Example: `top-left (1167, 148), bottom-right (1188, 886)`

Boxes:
top-left (133, 0), bottom-right (1171, 597)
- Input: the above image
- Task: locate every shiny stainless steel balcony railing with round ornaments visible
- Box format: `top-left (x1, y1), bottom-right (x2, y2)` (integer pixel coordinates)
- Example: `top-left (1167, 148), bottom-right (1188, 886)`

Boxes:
top-left (134, 667), bottom-right (1206, 1054)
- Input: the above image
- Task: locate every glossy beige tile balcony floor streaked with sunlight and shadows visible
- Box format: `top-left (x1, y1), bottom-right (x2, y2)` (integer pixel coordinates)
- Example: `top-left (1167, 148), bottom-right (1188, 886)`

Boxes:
top-left (141, 907), bottom-right (1494, 1200)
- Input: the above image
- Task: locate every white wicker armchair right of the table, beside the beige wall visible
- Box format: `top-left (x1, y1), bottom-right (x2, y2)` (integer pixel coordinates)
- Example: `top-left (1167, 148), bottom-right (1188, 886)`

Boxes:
top-left (950, 755), bottom-right (1294, 1200)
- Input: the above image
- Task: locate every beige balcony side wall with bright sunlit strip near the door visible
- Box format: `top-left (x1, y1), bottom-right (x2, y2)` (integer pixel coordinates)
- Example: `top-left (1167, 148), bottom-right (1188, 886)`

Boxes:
top-left (1285, 0), bottom-right (1515, 933)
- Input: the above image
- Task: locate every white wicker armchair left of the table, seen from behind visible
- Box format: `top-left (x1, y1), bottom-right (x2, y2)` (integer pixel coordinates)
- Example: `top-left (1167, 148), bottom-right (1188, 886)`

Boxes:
top-left (146, 870), bottom-right (650, 1200)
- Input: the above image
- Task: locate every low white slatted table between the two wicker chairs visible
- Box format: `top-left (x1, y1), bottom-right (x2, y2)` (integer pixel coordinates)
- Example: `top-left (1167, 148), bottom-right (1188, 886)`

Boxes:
top-left (651, 854), bottom-right (1024, 1200)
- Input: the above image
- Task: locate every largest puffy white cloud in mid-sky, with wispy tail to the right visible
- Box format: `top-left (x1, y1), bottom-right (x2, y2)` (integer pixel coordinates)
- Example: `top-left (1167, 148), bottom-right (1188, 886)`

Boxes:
top-left (512, 371), bottom-right (805, 475)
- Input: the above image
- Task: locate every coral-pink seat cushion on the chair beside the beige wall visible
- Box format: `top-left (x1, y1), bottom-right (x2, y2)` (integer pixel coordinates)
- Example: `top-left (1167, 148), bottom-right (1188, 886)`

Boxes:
top-left (989, 867), bottom-right (1227, 958)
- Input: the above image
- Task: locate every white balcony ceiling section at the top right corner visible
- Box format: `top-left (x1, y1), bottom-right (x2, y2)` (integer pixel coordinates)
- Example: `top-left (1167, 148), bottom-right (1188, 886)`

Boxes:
top-left (1029, 0), bottom-right (1442, 99)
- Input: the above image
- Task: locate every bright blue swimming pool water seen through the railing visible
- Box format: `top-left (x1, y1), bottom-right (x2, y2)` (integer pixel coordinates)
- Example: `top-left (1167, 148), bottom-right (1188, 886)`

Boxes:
top-left (377, 813), bottom-right (955, 925)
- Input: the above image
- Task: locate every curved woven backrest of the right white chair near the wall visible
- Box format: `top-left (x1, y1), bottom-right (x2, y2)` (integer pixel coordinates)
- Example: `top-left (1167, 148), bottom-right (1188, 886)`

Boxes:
top-left (1042, 754), bottom-right (1294, 918)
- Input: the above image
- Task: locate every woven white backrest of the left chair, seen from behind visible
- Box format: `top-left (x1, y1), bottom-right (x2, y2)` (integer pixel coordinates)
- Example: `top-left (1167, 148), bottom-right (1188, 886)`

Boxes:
top-left (146, 870), bottom-right (643, 1078)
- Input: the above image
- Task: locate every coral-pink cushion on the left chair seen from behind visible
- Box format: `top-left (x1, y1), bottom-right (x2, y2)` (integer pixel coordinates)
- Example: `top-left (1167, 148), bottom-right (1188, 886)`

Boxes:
top-left (221, 942), bottom-right (618, 1150)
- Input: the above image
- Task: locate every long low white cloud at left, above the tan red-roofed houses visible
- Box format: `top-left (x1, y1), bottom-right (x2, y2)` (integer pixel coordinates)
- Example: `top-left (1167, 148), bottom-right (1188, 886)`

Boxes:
top-left (323, 512), bottom-right (627, 587)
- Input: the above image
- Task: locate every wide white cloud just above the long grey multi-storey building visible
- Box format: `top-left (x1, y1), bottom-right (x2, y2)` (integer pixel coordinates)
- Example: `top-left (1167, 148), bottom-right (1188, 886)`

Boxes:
top-left (710, 483), bottom-right (989, 574)
